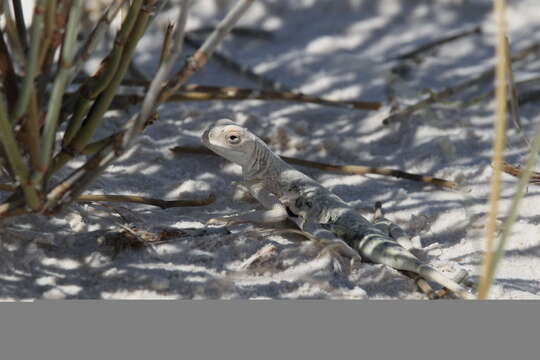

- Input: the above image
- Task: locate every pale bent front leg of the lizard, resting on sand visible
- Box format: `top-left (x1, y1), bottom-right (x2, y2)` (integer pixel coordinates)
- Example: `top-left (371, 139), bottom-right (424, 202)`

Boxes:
top-left (207, 183), bottom-right (288, 224)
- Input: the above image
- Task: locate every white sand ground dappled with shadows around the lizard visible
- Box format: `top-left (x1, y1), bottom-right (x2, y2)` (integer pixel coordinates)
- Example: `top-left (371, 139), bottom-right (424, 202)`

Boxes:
top-left (0, 0), bottom-right (540, 300)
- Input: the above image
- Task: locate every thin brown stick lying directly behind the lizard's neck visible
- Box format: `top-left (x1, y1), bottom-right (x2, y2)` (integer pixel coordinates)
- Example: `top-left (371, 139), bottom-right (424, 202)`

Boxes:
top-left (170, 146), bottom-right (458, 190)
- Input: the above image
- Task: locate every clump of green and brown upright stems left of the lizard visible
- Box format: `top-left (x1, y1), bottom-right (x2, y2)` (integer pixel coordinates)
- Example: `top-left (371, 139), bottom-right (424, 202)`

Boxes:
top-left (0, 0), bottom-right (253, 219)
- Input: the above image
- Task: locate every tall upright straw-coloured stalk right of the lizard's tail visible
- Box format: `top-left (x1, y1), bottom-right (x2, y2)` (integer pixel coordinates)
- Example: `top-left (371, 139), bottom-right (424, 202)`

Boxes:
top-left (478, 0), bottom-right (508, 299)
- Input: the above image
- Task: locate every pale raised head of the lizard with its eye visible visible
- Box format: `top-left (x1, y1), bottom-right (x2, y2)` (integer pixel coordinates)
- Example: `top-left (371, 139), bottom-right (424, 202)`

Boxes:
top-left (202, 119), bottom-right (258, 166)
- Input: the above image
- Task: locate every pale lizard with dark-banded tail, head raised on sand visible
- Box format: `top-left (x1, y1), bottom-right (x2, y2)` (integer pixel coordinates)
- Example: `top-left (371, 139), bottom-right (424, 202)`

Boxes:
top-left (201, 119), bottom-right (475, 299)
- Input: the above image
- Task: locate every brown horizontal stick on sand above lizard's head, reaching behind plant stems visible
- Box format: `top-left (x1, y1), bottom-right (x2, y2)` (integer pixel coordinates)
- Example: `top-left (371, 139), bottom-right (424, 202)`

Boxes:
top-left (110, 82), bottom-right (382, 110)
